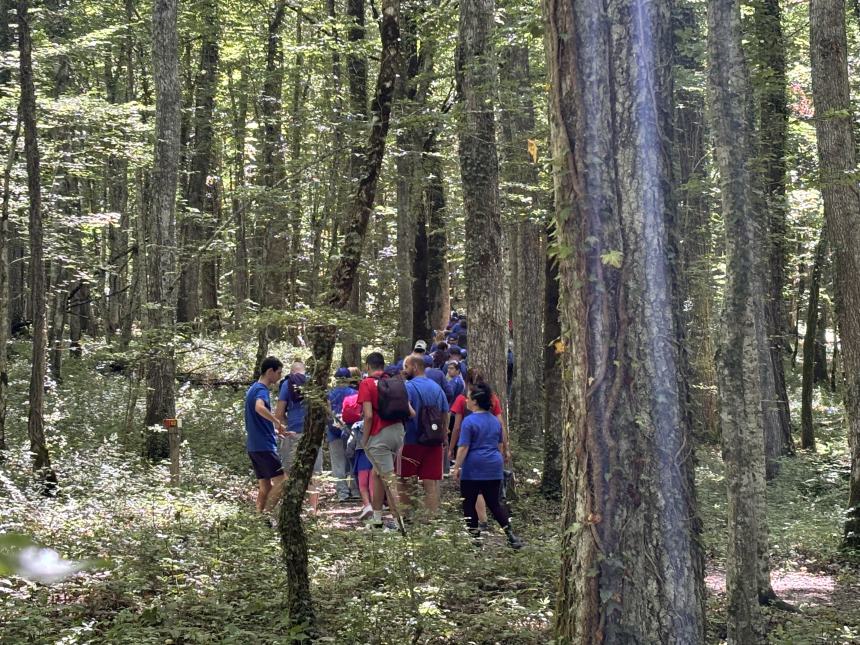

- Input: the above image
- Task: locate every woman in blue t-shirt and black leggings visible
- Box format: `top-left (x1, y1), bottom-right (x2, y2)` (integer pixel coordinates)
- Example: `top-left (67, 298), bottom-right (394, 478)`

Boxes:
top-left (454, 383), bottom-right (523, 549)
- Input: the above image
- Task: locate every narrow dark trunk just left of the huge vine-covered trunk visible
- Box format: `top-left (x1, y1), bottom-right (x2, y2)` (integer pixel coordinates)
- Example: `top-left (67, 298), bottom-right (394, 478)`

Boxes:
top-left (540, 244), bottom-right (564, 499)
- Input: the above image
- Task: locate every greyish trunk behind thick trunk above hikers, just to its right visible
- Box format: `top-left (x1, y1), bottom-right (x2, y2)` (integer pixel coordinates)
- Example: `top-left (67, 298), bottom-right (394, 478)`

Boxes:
top-left (499, 43), bottom-right (546, 444)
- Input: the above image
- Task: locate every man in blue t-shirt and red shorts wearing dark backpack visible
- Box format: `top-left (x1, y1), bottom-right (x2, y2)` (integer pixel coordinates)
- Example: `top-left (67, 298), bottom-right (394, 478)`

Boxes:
top-left (397, 355), bottom-right (448, 513)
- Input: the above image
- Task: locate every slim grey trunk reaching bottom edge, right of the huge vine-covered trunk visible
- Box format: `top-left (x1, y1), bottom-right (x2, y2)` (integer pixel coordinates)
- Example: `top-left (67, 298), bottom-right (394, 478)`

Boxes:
top-left (708, 0), bottom-right (772, 645)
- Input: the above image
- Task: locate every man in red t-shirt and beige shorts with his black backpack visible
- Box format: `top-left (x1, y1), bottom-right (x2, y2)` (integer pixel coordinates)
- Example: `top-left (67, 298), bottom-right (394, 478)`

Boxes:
top-left (357, 352), bottom-right (415, 530)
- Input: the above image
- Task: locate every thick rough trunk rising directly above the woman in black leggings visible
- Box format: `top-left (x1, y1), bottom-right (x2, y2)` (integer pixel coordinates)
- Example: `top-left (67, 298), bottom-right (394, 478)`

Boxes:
top-left (457, 0), bottom-right (508, 403)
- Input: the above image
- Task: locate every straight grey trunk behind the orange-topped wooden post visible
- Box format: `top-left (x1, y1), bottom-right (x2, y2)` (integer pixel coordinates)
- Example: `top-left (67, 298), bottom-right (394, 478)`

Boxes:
top-left (145, 0), bottom-right (181, 460)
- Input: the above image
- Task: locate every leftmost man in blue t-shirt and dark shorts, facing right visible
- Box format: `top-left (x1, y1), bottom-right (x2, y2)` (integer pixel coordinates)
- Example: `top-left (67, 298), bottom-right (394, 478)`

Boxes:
top-left (245, 356), bottom-right (286, 513)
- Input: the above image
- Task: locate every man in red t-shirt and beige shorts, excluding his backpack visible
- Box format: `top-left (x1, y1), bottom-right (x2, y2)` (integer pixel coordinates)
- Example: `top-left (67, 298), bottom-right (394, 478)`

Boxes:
top-left (357, 352), bottom-right (414, 527)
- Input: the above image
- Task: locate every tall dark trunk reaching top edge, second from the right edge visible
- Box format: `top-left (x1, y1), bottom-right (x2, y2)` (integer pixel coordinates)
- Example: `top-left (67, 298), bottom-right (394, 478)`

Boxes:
top-left (753, 0), bottom-right (794, 470)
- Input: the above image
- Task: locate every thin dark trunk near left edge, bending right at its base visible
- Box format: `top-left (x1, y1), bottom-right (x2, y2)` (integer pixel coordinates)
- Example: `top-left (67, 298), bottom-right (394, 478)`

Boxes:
top-left (18, 0), bottom-right (57, 493)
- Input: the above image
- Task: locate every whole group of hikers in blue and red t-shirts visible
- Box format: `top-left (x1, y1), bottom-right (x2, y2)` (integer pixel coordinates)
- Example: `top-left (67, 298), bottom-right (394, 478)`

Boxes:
top-left (245, 311), bottom-right (522, 549)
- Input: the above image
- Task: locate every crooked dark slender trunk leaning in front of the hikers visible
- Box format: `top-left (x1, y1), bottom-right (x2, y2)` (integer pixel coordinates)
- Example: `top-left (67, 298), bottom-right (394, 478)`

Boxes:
top-left (280, 0), bottom-right (400, 632)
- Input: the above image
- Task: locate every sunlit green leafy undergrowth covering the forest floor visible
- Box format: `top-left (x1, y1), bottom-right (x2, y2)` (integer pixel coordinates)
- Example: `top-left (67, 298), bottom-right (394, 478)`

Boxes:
top-left (0, 345), bottom-right (860, 644)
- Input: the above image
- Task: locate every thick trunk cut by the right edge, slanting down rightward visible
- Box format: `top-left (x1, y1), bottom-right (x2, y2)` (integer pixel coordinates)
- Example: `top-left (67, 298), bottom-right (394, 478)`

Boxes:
top-left (809, 0), bottom-right (860, 548)
